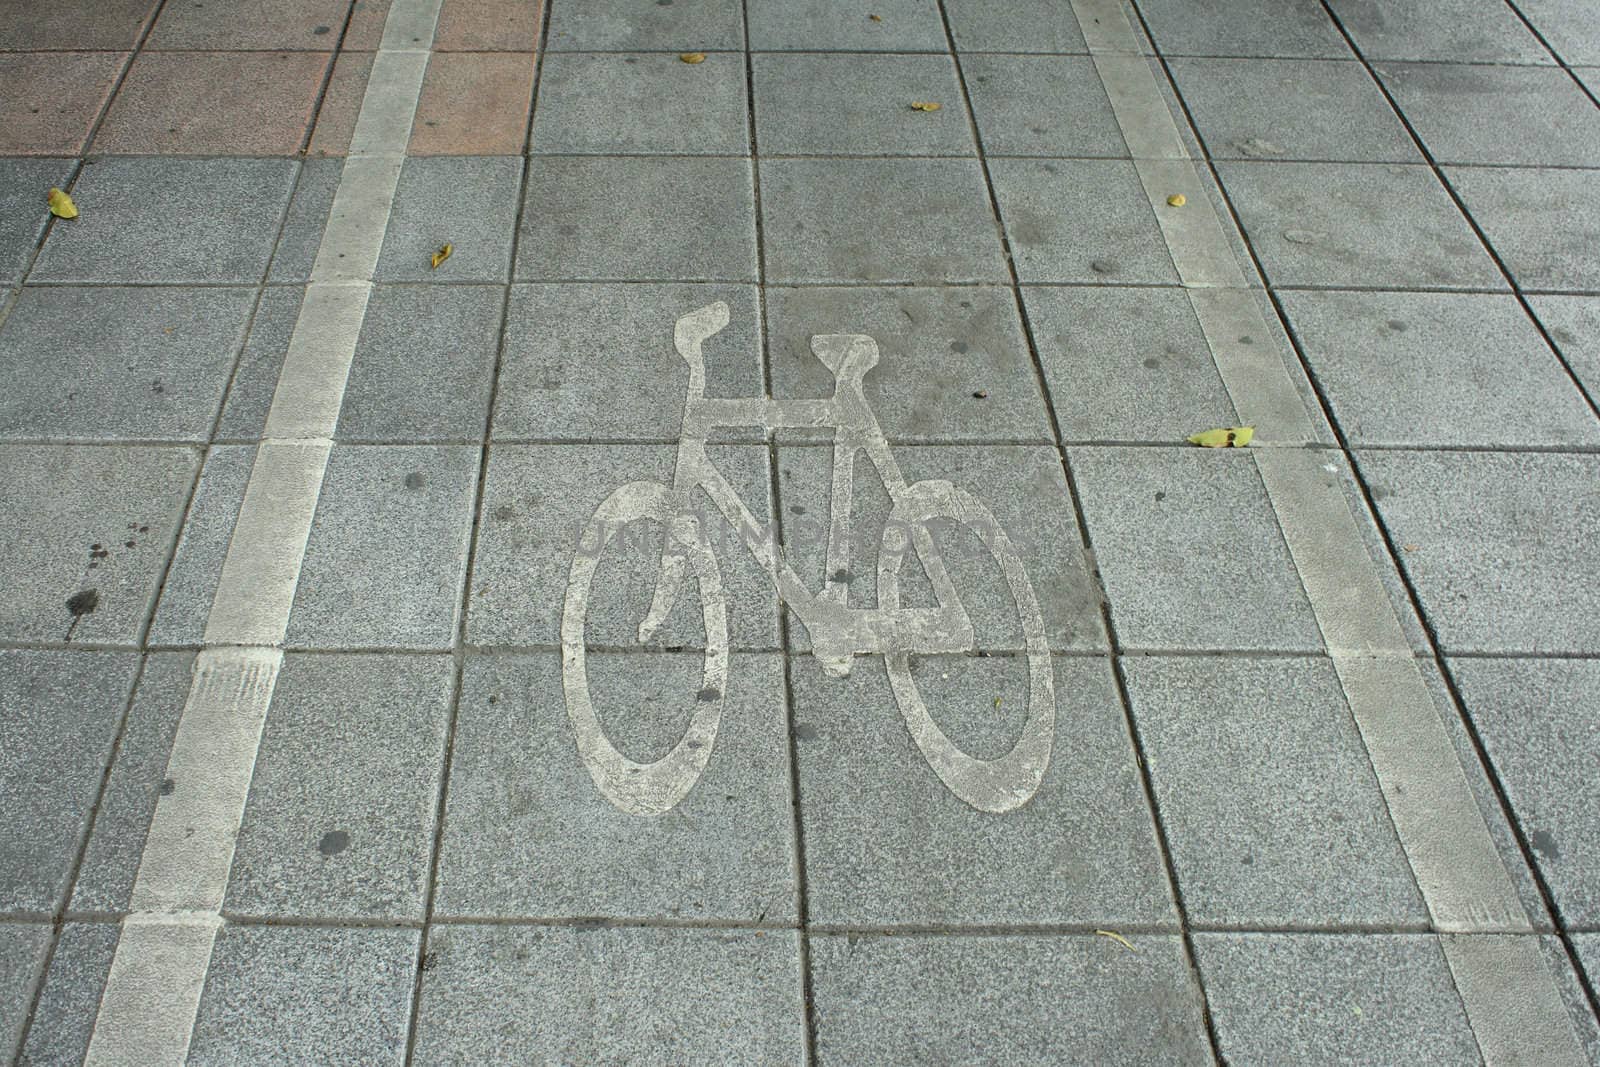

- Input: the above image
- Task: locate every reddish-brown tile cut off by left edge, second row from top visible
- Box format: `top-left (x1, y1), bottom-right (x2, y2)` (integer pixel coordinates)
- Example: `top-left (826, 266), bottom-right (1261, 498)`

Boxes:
top-left (0, 51), bottom-right (128, 155)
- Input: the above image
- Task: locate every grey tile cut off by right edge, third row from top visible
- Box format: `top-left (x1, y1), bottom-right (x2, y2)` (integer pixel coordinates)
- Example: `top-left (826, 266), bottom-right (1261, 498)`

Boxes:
top-left (1445, 166), bottom-right (1600, 293)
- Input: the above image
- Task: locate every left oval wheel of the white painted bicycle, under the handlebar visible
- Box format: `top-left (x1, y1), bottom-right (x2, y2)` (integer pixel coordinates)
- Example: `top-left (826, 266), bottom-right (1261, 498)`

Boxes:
top-left (562, 482), bottom-right (728, 816)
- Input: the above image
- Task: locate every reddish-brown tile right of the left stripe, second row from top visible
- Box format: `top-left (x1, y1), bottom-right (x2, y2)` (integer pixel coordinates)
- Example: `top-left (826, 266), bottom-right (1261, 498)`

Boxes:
top-left (411, 51), bottom-right (533, 155)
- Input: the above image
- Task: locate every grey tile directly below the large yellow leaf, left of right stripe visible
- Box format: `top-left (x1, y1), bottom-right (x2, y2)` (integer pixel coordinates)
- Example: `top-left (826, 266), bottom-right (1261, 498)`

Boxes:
top-left (1069, 448), bottom-right (1322, 651)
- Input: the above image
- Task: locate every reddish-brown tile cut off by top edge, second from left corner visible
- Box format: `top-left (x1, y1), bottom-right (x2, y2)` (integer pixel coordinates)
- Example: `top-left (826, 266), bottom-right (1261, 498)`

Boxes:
top-left (144, 0), bottom-right (350, 51)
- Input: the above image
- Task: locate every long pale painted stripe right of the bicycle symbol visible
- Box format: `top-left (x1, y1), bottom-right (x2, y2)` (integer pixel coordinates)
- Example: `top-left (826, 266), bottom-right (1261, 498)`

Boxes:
top-left (1072, 0), bottom-right (1586, 1067)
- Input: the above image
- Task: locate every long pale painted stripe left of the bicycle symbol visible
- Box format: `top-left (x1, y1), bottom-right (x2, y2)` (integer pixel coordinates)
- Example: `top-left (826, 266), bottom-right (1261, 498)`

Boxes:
top-left (83, 0), bottom-right (442, 1067)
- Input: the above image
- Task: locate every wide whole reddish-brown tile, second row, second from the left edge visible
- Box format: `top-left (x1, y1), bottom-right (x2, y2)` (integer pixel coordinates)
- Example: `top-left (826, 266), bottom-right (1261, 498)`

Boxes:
top-left (94, 51), bottom-right (333, 155)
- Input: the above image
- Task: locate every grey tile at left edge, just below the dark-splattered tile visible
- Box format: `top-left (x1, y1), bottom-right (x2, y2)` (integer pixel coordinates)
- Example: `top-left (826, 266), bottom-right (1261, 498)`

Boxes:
top-left (0, 649), bottom-right (139, 931)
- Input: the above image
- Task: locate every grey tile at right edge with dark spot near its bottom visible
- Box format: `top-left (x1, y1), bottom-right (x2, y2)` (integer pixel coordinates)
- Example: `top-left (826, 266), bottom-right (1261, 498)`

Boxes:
top-left (1450, 659), bottom-right (1600, 929)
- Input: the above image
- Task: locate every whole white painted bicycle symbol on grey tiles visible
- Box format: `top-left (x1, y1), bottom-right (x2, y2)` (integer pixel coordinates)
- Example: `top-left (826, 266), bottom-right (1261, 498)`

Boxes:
top-left (562, 301), bottom-right (1056, 816)
